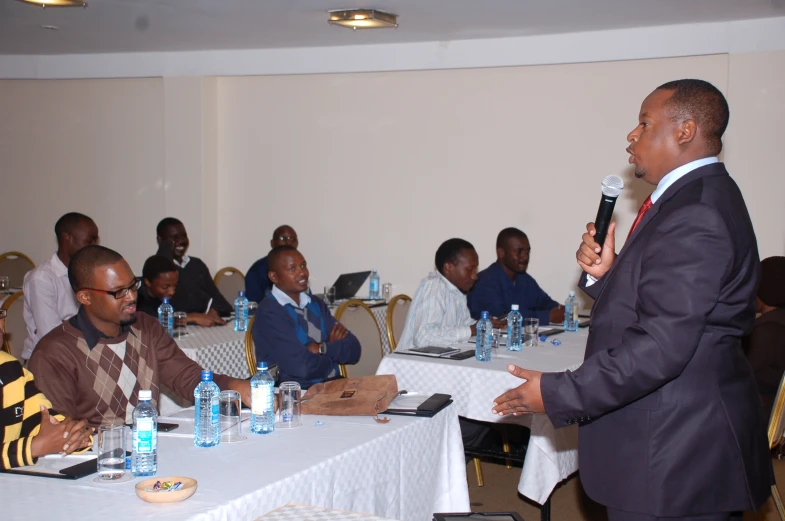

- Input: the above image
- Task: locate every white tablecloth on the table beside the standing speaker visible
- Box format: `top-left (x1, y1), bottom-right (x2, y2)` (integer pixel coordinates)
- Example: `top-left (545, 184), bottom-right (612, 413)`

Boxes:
top-left (376, 329), bottom-right (588, 504)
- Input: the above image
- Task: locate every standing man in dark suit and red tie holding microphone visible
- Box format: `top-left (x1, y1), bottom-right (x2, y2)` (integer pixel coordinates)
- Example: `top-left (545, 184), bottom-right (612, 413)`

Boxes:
top-left (493, 80), bottom-right (773, 521)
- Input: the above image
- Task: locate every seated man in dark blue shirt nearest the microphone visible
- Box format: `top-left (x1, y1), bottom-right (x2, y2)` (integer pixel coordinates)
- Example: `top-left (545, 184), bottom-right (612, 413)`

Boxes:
top-left (469, 228), bottom-right (564, 325)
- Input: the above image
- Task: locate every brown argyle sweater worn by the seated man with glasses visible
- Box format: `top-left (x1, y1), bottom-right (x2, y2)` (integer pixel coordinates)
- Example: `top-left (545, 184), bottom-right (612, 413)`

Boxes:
top-left (30, 308), bottom-right (230, 425)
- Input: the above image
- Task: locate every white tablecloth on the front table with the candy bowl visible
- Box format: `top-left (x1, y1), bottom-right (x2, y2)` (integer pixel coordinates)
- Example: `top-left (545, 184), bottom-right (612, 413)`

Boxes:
top-left (0, 407), bottom-right (469, 521)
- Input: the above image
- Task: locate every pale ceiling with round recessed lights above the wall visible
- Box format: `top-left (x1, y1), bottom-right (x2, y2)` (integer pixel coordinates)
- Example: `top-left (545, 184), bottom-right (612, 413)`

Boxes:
top-left (0, 0), bottom-right (785, 54)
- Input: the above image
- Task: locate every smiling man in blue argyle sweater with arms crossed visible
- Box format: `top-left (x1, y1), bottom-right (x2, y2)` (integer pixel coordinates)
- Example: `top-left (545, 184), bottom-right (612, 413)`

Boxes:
top-left (251, 246), bottom-right (360, 389)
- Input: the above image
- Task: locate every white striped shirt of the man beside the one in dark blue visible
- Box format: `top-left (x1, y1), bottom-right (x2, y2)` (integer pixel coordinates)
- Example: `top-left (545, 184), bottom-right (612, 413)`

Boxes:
top-left (398, 272), bottom-right (475, 350)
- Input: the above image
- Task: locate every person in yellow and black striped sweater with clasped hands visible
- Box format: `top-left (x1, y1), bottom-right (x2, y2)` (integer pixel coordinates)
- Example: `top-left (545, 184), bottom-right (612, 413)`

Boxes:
top-left (0, 309), bottom-right (93, 470)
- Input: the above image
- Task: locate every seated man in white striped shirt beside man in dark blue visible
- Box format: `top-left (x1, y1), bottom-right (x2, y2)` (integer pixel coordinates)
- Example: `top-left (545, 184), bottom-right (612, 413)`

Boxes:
top-left (398, 239), bottom-right (507, 350)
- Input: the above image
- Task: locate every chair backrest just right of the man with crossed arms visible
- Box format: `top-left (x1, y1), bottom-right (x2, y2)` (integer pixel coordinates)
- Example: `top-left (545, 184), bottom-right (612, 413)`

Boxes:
top-left (335, 300), bottom-right (384, 376)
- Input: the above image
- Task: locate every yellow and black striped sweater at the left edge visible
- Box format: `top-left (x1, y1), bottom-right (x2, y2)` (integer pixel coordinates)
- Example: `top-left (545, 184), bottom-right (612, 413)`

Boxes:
top-left (0, 351), bottom-right (64, 469)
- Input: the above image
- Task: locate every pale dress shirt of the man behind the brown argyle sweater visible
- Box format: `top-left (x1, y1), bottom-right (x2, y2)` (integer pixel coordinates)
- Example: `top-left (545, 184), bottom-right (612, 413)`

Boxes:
top-left (22, 253), bottom-right (79, 360)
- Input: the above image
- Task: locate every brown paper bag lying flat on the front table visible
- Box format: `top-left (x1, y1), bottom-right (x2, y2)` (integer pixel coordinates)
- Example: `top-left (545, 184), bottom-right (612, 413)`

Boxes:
top-left (302, 374), bottom-right (398, 416)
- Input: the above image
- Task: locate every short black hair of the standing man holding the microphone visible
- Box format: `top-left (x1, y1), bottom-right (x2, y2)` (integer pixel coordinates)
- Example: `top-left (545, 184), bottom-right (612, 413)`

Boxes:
top-left (657, 79), bottom-right (730, 156)
